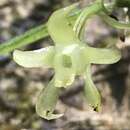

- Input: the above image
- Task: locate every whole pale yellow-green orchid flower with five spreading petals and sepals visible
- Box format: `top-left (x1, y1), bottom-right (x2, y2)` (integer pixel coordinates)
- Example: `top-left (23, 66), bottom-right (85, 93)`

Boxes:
top-left (13, 4), bottom-right (121, 120)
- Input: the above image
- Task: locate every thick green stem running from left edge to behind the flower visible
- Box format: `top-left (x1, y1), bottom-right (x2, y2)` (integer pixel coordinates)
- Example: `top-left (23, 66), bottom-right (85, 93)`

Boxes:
top-left (0, 24), bottom-right (49, 55)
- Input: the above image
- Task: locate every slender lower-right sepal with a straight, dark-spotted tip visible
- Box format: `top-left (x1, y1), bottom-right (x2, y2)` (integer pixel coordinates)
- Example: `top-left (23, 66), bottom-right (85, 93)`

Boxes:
top-left (84, 65), bottom-right (101, 112)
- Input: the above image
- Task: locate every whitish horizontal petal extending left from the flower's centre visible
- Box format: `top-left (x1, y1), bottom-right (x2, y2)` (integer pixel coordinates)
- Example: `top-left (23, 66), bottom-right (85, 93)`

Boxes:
top-left (13, 46), bottom-right (55, 67)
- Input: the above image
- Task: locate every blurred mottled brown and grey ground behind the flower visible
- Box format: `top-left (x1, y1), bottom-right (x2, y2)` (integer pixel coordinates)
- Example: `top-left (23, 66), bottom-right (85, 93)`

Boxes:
top-left (0, 0), bottom-right (130, 130)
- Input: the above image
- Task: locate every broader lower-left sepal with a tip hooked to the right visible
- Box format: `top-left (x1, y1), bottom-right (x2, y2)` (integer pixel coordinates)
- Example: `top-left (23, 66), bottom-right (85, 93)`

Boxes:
top-left (36, 79), bottom-right (63, 120)
